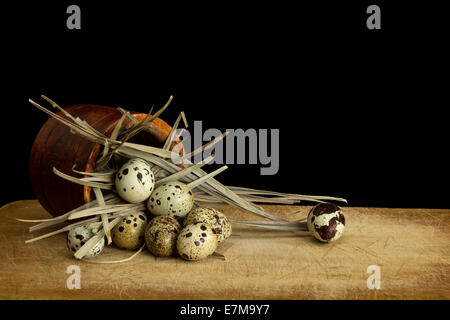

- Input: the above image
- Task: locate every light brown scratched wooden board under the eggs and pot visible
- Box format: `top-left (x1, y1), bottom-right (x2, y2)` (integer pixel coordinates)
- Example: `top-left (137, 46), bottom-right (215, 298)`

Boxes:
top-left (0, 200), bottom-right (450, 299)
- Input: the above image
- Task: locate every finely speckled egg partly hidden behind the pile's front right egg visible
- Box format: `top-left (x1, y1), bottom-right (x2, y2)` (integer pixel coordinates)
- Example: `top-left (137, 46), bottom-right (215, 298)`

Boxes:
top-left (183, 207), bottom-right (232, 243)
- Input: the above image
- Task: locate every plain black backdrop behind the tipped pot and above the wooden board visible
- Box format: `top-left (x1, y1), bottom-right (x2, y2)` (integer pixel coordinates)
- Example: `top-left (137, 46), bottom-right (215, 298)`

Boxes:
top-left (1, 1), bottom-right (450, 208)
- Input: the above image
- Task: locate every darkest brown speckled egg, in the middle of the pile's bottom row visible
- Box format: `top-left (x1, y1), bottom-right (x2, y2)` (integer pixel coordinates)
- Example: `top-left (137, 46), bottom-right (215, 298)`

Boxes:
top-left (145, 216), bottom-right (181, 257)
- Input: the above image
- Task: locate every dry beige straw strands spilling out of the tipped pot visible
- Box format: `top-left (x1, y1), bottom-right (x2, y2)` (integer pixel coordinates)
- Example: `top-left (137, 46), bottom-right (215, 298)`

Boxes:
top-left (19, 96), bottom-right (346, 259)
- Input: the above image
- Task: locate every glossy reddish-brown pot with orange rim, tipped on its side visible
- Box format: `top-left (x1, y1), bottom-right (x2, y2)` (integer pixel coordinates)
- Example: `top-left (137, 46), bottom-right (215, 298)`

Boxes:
top-left (29, 104), bottom-right (171, 216)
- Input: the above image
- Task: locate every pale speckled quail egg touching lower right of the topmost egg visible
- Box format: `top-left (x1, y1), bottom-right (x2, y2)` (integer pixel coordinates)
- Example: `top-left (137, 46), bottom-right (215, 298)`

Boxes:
top-left (147, 181), bottom-right (194, 219)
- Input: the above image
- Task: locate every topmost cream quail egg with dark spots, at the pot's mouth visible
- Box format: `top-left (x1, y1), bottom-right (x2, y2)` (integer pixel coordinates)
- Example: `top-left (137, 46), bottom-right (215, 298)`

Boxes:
top-left (115, 158), bottom-right (155, 203)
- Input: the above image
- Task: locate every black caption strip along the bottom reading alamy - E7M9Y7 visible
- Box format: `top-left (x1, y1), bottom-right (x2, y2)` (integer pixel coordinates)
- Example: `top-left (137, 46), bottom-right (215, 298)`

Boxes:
top-left (0, 300), bottom-right (448, 319)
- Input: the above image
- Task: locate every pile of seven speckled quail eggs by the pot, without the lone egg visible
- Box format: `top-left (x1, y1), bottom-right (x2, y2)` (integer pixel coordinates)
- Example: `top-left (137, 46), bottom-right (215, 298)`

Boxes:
top-left (67, 158), bottom-right (236, 261)
